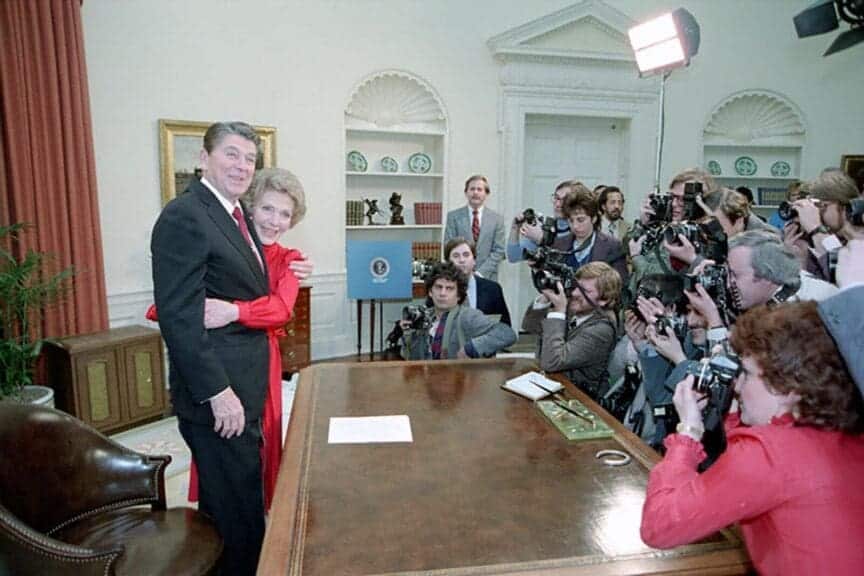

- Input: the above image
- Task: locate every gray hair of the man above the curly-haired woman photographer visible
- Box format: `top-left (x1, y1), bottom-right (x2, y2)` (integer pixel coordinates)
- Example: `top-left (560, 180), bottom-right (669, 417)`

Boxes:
top-left (729, 230), bottom-right (801, 290)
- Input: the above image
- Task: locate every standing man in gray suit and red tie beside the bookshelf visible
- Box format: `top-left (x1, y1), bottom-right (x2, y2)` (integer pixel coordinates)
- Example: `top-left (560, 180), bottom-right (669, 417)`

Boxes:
top-left (444, 174), bottom-right (505, 280)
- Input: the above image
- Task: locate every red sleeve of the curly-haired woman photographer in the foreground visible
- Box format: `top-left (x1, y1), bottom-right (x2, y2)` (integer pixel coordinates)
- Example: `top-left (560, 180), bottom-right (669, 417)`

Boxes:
top-left (641, 429), bottom-right (785, 548)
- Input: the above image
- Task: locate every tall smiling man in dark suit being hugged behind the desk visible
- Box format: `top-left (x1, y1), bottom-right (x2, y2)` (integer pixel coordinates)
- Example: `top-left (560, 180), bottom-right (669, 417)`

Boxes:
top-left (151, 122), bottom-right (268, 574)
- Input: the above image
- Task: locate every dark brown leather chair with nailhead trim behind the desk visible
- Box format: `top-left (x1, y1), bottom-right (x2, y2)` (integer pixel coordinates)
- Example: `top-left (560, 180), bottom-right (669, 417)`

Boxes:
top-left (0, 402), bottom-right (222, 576)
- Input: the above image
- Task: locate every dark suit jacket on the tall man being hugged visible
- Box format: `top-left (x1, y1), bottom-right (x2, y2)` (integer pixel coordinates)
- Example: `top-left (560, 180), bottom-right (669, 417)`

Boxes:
top-left (150, 181), bottom-right (269, 424)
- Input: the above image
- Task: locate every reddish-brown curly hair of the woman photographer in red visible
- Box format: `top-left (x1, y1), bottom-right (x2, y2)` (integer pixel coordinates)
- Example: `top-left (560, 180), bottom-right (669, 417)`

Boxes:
top-left (730, 302), bottom-right (864, 432)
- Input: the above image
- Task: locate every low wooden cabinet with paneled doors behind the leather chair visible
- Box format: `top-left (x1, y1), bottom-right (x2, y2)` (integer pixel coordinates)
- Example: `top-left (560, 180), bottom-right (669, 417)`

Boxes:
top-left (45, 326), bottom-right (168, 433)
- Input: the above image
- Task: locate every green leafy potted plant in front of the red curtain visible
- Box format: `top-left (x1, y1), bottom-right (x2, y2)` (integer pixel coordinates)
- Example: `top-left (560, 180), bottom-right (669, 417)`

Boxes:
top-left (0, 223), bottom-right (74, 403)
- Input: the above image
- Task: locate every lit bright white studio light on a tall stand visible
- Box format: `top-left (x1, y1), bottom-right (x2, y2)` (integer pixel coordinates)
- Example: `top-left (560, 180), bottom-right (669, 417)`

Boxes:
top-left (627, 8), bottom-right (699, 76)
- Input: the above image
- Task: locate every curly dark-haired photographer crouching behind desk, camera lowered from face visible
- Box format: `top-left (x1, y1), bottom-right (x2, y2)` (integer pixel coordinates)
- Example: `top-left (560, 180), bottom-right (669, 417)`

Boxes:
top-left (400, 262), bottom-right (516, 360)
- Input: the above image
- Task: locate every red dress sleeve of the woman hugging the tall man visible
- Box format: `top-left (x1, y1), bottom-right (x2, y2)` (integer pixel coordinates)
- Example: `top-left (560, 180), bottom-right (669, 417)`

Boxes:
top-left (234, 244), bottom-right (301, 328)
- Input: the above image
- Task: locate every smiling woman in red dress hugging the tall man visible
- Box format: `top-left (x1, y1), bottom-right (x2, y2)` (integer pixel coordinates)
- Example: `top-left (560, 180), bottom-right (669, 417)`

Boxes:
top-left (147, 168), bottom-right (312, 510)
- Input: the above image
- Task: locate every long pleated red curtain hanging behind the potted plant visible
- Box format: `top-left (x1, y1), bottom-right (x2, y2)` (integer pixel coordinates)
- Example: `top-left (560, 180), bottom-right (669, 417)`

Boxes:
top-left (0, 0), bottom-right (108, 336)
